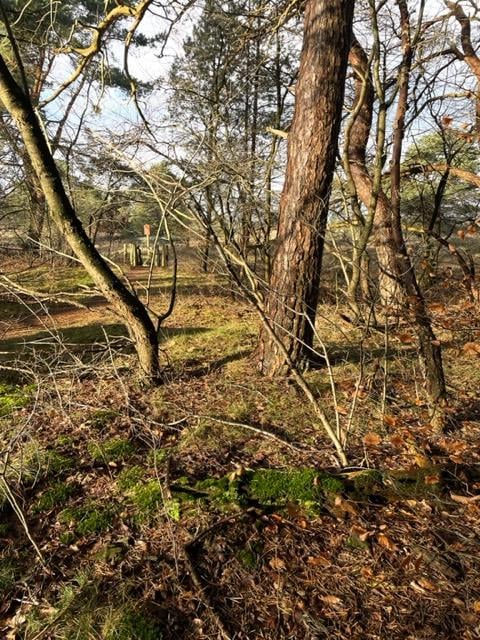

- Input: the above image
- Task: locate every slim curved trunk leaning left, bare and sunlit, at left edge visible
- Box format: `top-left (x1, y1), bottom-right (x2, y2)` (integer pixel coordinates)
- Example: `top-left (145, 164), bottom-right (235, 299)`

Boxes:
top-left (0, 56), bottom-right (160, 380)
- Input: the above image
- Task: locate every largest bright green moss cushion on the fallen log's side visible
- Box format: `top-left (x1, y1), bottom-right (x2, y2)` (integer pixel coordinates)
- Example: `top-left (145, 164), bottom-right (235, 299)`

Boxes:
top-left (247, 469), bottom-right (320, 505)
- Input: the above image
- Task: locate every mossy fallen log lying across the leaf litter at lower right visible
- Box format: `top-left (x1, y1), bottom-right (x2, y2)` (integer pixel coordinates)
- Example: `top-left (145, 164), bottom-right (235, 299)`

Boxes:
top-left (167, 465), bottom-right (480, 514)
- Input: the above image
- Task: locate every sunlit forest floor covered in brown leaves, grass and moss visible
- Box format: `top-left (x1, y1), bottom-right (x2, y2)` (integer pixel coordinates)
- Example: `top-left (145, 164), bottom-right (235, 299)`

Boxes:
top-left (0, 252), bottom-right (480, 640)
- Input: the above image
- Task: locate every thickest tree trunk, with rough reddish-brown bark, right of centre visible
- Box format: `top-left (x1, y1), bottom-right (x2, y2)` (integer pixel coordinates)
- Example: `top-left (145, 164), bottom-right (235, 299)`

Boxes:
top-left (258, 0), bottom-right (354, 376)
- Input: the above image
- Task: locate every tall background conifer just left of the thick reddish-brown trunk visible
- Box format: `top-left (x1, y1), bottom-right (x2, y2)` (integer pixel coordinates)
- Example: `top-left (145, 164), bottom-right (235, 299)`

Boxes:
top-left (170, 0), bottom-right (294, 270)
